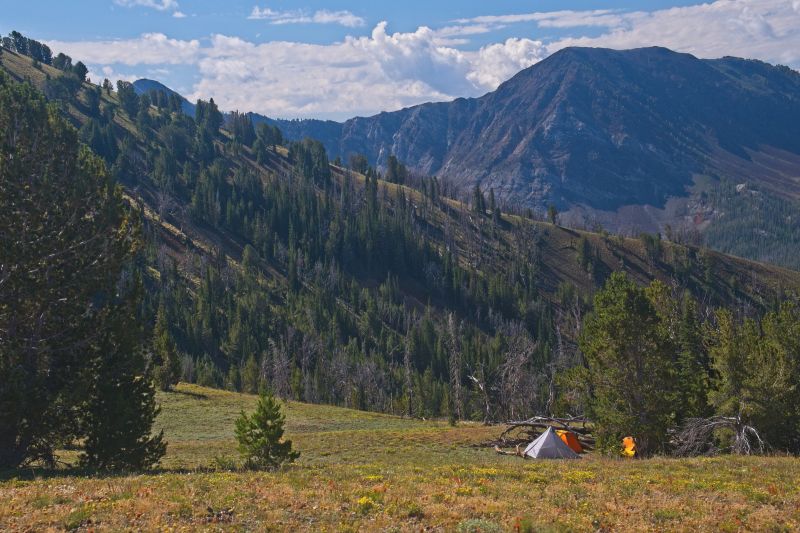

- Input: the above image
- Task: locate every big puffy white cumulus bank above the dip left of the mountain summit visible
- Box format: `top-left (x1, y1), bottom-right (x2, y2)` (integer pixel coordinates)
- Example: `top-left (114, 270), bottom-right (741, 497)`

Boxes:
top-left (187, 22), bottom-right (545, 118)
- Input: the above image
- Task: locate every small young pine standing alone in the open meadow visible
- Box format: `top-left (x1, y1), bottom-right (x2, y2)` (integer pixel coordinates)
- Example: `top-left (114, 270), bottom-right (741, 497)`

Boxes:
top-left (235, 388), bottom-right (300, 469)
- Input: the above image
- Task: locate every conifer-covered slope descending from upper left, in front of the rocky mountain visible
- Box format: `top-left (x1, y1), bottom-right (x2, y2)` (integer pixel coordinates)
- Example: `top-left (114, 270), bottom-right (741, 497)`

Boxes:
top-left (0, 41), bottom-right (800, 418)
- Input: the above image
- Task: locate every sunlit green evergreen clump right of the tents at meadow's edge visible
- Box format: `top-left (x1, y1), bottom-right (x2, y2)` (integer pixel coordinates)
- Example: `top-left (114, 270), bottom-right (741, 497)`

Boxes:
top-left (572, 273), bottom-right (800, 455)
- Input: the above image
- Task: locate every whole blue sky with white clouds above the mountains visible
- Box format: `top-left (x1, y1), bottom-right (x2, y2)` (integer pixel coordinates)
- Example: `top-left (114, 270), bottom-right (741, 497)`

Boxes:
top-left (0, 0), bottom-right (800, 120)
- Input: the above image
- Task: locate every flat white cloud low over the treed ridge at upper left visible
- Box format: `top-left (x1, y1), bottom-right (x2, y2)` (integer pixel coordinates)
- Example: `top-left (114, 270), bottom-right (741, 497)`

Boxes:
top-left (47, 33), bottom-right (200, 66)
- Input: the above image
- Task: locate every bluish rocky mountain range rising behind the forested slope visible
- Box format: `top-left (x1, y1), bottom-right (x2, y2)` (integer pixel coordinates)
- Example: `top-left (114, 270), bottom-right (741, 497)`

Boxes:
top-left (137, 47), bottom-right (800, 258)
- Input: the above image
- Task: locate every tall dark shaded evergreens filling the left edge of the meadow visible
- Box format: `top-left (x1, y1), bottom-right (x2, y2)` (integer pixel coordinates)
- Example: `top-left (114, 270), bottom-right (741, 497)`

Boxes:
top-left (0, 73), bottom-right (165, 469)
